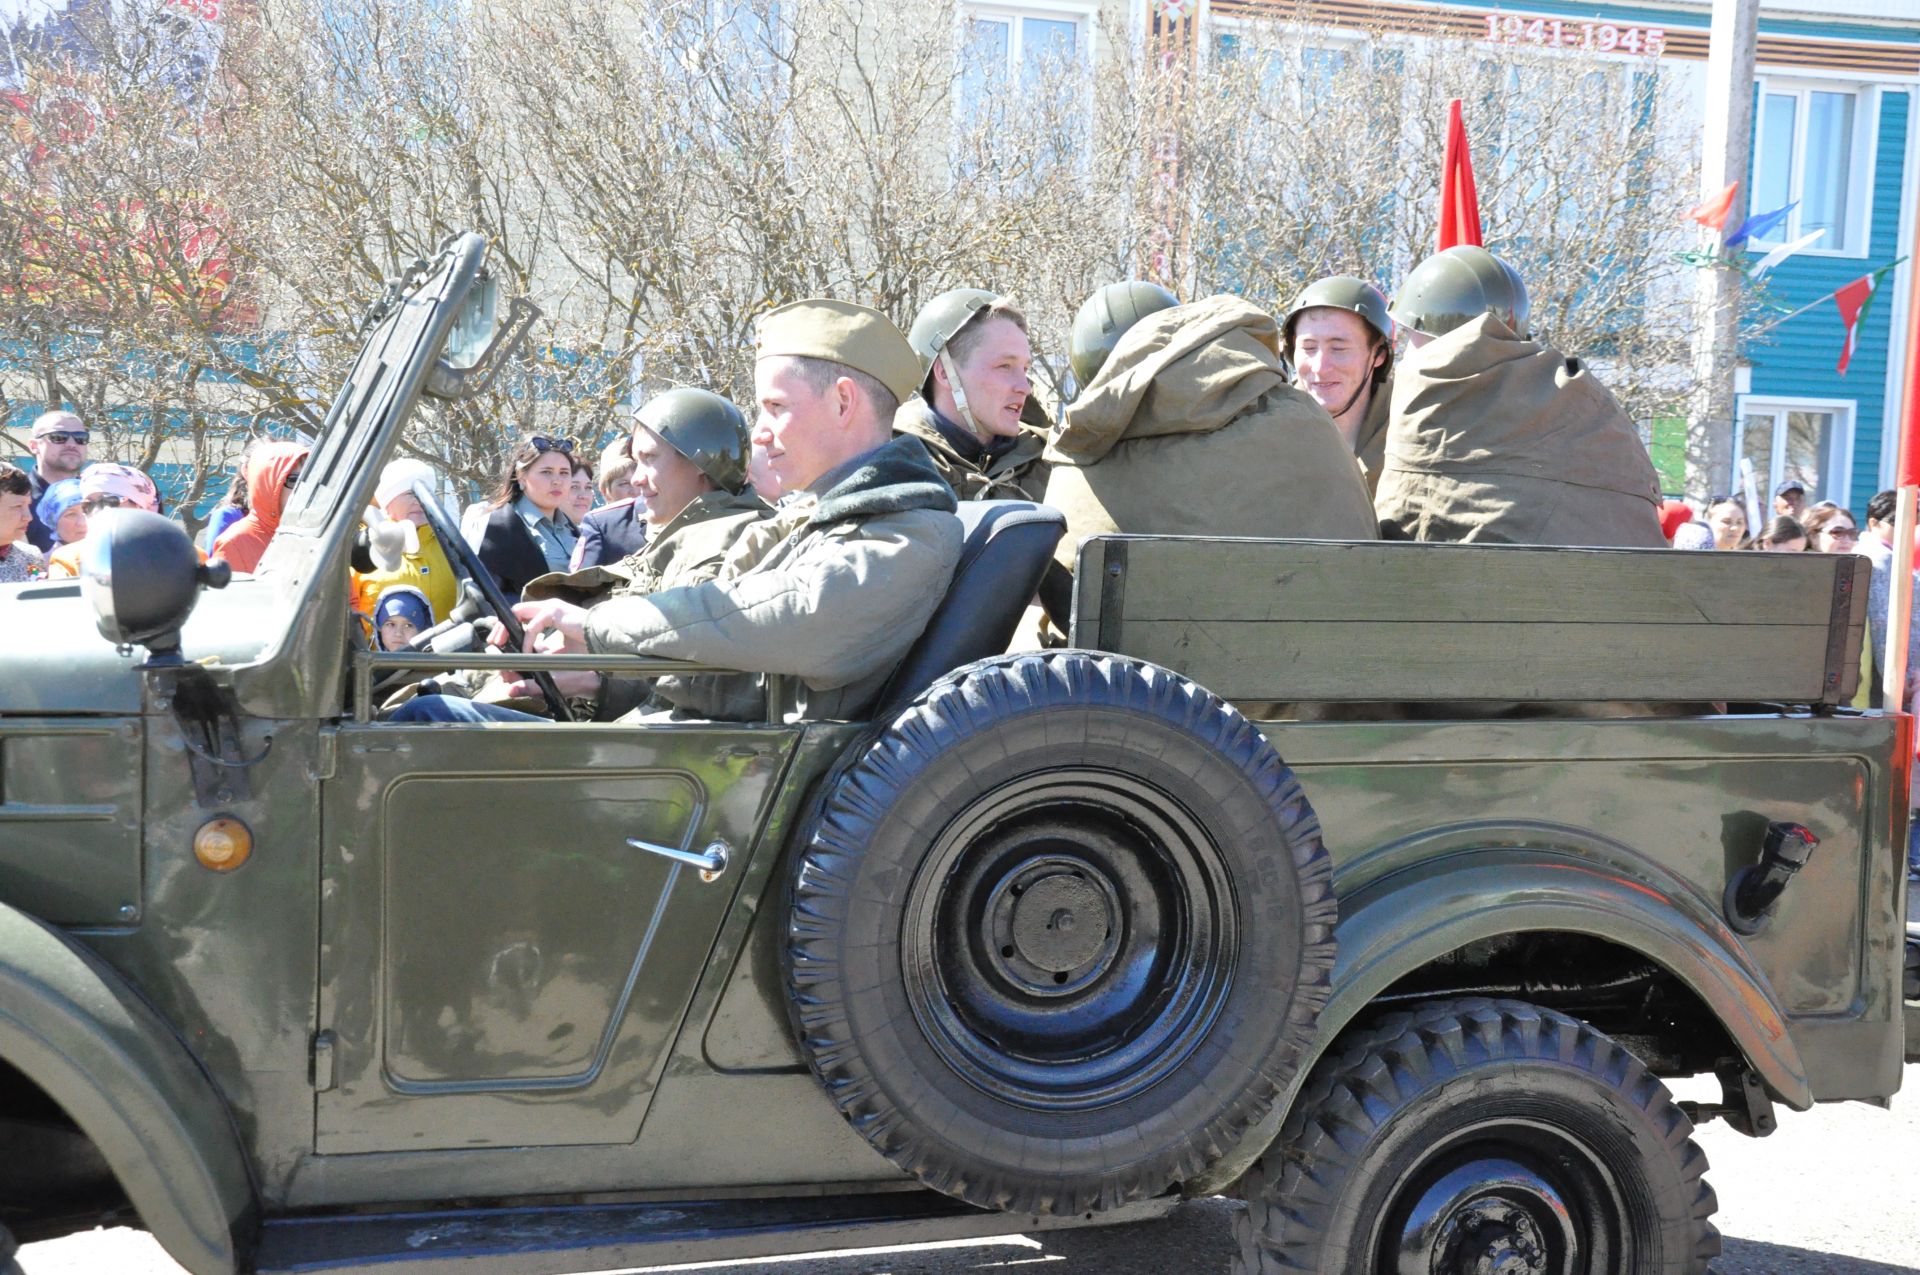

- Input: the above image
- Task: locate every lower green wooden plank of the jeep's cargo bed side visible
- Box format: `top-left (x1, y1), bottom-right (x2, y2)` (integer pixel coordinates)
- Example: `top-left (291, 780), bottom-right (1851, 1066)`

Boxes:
top-left (1119, 620), bottom-right (1826, 703)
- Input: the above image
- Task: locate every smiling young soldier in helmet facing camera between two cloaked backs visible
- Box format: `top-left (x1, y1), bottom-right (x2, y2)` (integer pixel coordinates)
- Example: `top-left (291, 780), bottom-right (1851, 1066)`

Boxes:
top-left (1281, 275), bottom-right (1394, 495)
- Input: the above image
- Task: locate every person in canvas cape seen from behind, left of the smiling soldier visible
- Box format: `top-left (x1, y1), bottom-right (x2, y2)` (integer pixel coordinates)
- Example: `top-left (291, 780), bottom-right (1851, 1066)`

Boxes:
top-left (1046, 282), bottom-right (1379, 587)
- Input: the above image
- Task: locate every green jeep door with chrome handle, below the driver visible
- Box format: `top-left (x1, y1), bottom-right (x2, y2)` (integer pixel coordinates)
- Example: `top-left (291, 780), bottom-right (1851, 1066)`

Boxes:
top-left (315, 724), bottom-right (799, 1152)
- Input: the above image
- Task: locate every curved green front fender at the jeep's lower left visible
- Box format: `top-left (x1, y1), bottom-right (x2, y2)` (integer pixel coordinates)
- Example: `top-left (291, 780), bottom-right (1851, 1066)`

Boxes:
top-left (0, 904), bottom-right (257, 1275)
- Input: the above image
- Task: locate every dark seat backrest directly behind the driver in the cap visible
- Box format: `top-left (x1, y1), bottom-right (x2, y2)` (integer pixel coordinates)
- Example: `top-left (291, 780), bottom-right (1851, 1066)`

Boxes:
top-left (877, 501), bottom-right (1068, 714)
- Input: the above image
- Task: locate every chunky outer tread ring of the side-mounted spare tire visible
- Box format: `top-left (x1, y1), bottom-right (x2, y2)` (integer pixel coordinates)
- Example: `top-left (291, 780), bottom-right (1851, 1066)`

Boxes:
top-left (783, 651), bottom-right (1338, 1214)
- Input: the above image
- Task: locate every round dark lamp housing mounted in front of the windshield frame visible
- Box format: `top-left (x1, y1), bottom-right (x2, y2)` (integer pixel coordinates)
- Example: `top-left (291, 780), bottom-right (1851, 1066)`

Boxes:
top-left (81, 509), bottom-right (232, 664)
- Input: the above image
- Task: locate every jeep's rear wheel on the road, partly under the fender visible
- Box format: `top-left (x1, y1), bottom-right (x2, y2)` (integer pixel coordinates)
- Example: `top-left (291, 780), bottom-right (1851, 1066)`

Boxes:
top-left (1235, 998), bottom-right (1720, 1275)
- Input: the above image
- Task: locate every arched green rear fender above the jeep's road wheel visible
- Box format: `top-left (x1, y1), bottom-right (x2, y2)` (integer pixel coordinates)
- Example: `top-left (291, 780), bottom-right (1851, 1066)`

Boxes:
top-left (1185, 844), bottom-right (1812, 1194)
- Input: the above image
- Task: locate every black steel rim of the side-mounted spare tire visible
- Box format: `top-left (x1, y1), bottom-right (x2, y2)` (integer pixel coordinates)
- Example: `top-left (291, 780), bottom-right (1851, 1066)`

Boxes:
top-left (900, 768), bottom-right (1240, 1110)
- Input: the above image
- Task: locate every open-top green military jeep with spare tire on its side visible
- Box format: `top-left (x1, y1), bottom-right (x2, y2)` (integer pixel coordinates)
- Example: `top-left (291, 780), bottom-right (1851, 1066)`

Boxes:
top-left (0, 236), bottom-right (1910, 1275)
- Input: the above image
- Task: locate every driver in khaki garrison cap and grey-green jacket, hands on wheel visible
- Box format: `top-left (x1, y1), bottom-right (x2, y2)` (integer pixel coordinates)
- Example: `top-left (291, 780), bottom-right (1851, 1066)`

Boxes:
top-left (515, 291), bottom-right (962, 720)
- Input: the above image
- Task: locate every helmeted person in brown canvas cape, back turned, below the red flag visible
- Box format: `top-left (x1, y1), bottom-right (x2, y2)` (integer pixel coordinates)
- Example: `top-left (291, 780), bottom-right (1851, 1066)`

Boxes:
top-left (1375, 246), bottom-right (1667, 549)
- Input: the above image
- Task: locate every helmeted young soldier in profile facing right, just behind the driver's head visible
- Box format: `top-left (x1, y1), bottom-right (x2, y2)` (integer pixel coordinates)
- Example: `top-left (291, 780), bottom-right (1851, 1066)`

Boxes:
top-left (893, 288), bottom-right (1046, 499)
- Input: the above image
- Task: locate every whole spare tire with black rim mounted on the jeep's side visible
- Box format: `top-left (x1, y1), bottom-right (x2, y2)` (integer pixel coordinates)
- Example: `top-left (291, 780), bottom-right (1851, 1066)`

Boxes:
top-left (785, 651), bottom-right (1336, 1214)
